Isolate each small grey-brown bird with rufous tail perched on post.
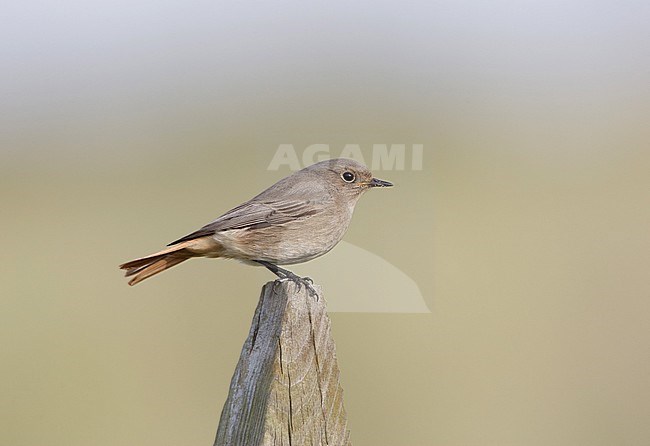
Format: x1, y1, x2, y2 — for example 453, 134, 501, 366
120, 158, 392, 285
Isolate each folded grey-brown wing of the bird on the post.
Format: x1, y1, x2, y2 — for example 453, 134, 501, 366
167, 200, 323, 246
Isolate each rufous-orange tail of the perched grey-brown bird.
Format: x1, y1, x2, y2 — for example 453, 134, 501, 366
120, 240, 216, 285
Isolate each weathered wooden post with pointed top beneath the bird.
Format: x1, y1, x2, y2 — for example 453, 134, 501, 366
214, 279, 351, 446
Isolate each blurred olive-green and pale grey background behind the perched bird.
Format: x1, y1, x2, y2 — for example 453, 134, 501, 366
0, 0, 650, 446
